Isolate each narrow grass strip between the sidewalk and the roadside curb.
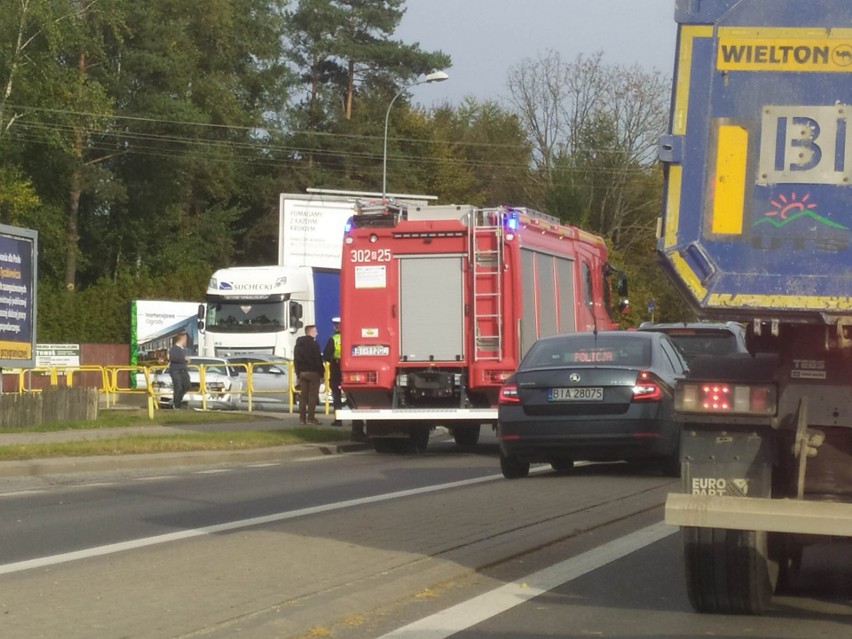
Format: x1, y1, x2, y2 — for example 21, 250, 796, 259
0, 428, 346, 461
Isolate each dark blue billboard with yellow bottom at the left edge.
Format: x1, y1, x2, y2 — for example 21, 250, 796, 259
0, 224, 38, 368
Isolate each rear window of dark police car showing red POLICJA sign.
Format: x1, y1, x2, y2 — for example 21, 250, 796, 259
520, 336, 651, 370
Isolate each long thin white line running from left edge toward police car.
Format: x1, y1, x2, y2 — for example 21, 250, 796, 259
0, 475, 503, 575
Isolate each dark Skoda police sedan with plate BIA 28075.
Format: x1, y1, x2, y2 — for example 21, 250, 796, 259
497, 331, 687, 479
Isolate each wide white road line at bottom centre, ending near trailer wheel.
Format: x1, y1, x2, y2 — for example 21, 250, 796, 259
378, 522, 678, 639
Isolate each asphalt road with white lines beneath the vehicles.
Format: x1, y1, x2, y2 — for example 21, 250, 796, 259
0, 431, 852, 639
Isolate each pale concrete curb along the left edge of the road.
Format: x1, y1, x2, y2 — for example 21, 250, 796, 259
0, 442, 369, 477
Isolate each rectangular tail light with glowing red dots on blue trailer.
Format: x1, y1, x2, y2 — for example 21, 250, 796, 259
675, 382, 776, 415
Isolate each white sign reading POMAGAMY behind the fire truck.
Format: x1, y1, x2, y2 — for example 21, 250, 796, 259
278, 194, 355, 270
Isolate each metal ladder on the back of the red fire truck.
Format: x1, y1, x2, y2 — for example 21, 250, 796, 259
468, 209, 503, 361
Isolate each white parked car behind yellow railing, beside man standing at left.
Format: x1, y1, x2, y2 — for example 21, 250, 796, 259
151, 357, 244, 410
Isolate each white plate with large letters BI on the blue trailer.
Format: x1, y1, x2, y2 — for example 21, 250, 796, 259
757, 104, 852, 186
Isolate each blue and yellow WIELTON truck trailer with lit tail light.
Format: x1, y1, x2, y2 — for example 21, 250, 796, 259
658, 0, 852, 613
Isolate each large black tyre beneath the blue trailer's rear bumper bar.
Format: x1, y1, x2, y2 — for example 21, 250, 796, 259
681, 527, 777, 615
